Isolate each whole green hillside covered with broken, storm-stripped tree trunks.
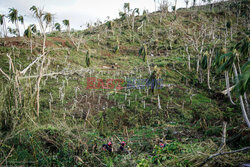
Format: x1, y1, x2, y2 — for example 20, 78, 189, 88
0, 0, 250, 166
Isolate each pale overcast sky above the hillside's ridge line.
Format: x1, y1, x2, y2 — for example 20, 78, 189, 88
0, 0, 188, 32
